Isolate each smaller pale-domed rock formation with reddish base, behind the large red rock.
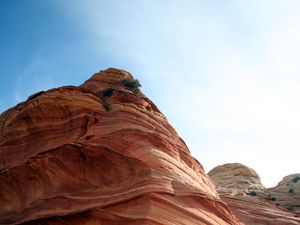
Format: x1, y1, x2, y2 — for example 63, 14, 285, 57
208, 163, 300, 225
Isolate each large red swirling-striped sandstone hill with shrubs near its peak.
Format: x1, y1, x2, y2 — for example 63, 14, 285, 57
0, 69, 240, 225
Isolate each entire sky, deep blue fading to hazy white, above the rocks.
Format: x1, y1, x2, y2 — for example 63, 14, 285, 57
0, 0, 300, 186
